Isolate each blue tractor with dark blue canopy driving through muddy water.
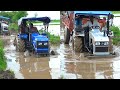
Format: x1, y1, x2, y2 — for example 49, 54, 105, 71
14, 17, 50, 55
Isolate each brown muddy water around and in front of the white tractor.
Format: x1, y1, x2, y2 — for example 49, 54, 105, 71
60, 28, 120, 79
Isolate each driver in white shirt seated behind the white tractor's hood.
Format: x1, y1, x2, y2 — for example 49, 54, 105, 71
82, 16, 100, 28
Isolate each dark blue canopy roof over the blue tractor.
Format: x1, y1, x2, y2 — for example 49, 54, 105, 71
18, 17, 51, 25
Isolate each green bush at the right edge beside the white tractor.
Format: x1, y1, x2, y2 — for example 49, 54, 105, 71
110, 26, 120, 45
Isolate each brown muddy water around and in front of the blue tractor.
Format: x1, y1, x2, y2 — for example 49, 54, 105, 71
4, 36, 60, 79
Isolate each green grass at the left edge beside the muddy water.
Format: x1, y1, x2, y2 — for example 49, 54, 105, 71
0, 40, 7, 70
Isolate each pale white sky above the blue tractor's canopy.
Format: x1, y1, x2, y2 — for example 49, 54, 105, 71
27, 11, 60, 19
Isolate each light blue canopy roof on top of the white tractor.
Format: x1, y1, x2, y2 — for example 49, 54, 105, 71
74, 11, 112, 15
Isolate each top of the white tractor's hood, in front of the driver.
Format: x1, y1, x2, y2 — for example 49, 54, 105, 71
90, 29, 109, 41
